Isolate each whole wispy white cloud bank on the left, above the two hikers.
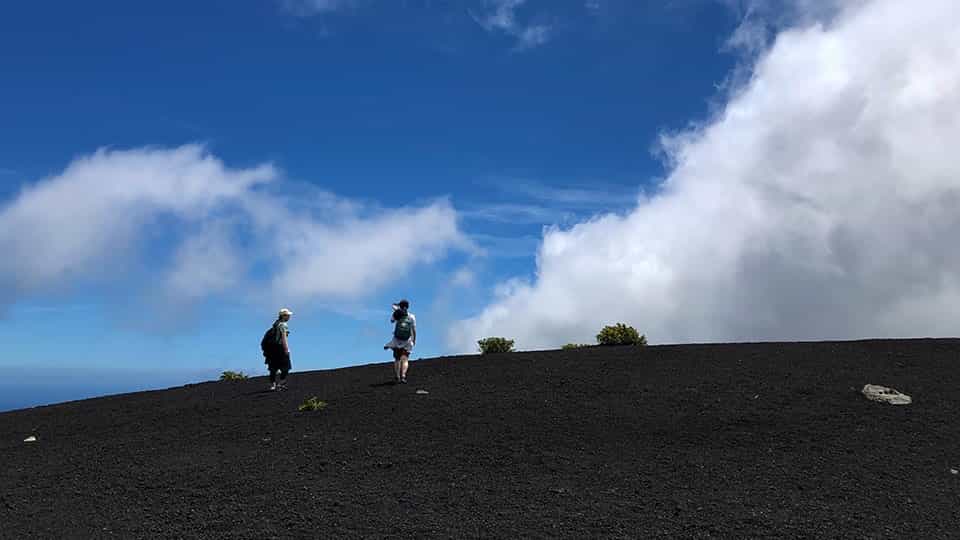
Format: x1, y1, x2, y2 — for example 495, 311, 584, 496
0, 145, 468, 312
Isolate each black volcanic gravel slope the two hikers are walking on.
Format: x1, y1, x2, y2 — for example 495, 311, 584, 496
0, 340, 960, 539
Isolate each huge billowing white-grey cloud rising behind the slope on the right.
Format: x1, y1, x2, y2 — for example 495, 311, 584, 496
449, 0, 960, 351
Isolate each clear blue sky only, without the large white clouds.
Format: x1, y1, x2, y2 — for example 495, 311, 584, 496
0, 0, 736, 376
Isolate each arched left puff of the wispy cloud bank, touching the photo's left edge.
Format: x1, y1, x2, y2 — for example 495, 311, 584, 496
0, 145, 277, 291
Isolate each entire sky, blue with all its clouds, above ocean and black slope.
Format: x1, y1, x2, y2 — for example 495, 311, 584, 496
0, 0, 960, 408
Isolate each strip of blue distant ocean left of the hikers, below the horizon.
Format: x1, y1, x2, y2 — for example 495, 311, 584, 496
0, 366, 223, 412
